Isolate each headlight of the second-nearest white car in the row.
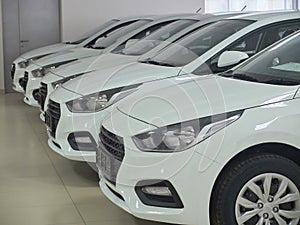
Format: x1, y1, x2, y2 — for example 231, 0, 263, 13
66, 84, 141, 113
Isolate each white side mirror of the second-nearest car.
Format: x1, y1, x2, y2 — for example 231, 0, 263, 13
218, 51, 249, 67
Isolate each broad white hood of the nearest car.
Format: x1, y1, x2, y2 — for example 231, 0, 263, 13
115, 75, 298, 127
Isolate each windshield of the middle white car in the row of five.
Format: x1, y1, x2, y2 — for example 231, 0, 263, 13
121, 19, 197, 56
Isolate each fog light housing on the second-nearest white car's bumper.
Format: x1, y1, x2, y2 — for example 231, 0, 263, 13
68, 132, 97, 151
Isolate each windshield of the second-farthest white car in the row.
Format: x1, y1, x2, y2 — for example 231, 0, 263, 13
92, 20, 151, 49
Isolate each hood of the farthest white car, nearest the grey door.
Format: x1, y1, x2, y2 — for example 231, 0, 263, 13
20, 43, 76, 59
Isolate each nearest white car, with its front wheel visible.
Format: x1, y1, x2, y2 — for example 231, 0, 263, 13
97, 33, 300, 225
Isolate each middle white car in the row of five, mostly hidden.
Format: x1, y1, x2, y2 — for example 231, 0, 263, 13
38, 13, 241, 120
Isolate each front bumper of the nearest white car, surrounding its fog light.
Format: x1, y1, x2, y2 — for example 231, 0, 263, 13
96, 111, 221, 225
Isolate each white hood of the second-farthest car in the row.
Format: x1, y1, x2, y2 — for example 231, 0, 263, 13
33, 48, 102, 67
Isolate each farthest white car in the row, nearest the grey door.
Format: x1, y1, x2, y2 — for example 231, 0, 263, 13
11, 17, 140, 93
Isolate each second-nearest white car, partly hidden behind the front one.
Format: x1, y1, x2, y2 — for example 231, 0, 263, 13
46, 12, 300, 162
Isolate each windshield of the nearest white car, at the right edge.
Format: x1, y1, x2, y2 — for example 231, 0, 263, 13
220, 33, 300, 85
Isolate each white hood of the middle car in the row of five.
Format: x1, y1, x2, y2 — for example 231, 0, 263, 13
52, 53, 138, 78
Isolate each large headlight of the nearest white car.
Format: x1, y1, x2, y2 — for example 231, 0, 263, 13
132, 111, 243, 152
